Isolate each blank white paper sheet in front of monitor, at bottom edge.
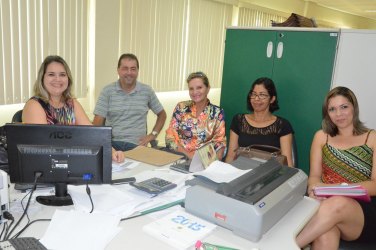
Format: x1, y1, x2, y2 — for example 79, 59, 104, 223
41, 210, 121, 250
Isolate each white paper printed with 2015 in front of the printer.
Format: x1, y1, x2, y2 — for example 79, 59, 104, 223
143, 210, 216, 249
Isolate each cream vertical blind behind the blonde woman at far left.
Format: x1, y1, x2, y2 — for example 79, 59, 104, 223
0, 0, 88, 105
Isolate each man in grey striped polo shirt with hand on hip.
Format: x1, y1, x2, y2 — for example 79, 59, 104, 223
93, 54, 166, 151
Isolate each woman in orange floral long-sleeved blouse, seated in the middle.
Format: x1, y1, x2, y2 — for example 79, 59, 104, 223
166, 72, 226, 159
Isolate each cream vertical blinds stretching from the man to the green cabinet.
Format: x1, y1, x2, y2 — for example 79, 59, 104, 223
119, 0, 232, 92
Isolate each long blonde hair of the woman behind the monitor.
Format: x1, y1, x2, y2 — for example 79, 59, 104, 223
34, 55, 73, 103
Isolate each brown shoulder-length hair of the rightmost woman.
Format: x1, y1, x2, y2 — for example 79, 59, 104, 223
322, 86, 369, 136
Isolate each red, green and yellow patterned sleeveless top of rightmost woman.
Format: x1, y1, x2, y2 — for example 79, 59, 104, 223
321, 130, 373, 184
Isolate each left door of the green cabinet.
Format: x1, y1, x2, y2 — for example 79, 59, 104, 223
220, 29, 276, 139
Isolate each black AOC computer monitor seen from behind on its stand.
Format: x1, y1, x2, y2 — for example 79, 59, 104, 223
5, 123, 112, 206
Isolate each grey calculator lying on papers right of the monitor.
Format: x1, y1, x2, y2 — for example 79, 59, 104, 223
129, 177, 177, 194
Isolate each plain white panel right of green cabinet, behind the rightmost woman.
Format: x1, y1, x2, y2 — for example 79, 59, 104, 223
332, 30, 376, 129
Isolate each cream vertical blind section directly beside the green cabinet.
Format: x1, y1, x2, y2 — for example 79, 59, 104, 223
181, 0, 233, 89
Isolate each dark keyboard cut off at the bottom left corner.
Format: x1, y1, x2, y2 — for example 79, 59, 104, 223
0, 237, 47, 250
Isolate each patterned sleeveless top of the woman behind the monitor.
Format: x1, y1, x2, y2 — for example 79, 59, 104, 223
31, 96, 76, 125
